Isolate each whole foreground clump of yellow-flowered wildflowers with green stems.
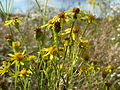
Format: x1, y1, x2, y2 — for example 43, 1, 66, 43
0, 0, 118, 90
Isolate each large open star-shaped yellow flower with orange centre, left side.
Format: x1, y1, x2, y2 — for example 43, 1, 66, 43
8, 52, 26, 65
